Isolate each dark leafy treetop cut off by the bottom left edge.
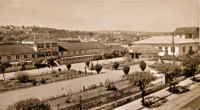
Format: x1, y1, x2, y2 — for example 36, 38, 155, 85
7, 98, 51, 110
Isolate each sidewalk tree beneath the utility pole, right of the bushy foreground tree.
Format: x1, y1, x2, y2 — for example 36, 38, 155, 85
157, 64, 178, 91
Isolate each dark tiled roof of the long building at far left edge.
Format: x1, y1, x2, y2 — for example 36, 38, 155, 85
0, 44, 36, 56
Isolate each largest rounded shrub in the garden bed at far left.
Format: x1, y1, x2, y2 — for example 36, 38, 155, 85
15, 72, 30, 83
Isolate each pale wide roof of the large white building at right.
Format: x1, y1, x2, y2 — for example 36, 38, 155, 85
133, 36, 198, 45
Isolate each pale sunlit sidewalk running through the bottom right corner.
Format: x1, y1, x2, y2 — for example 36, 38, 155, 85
114, 75, 200, 110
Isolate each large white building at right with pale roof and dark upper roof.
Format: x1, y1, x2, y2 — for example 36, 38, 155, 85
132, 28, 199, 56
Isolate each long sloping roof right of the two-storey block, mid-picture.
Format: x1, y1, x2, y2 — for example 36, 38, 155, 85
58, 42, 106, 50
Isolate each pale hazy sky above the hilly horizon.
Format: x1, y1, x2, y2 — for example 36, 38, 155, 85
0, 0, 199, 32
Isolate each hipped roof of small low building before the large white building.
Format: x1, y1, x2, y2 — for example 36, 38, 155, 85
128, 45, 162, 53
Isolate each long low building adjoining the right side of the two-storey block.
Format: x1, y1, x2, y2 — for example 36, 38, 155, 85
57, 42, 106, 64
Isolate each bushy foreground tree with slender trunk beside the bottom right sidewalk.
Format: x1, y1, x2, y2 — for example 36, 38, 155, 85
128, 71, 156, 104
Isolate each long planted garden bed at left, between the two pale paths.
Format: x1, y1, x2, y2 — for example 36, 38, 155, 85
0, 70, 94, 93
